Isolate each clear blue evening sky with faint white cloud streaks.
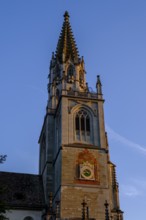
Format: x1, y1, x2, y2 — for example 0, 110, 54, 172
0, 0, 146, 220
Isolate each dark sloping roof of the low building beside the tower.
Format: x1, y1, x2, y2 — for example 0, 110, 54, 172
0, 172, 44, 210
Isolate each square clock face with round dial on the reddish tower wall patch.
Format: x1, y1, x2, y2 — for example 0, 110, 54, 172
80, 164, 95, 180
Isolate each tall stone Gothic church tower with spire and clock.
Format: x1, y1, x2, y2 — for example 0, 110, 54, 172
39, 12, 123, 220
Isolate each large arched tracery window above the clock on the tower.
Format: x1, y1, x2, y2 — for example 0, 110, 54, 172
75, 109, 91, 142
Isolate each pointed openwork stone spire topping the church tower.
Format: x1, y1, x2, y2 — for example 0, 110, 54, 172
56, 11, 79, 63
